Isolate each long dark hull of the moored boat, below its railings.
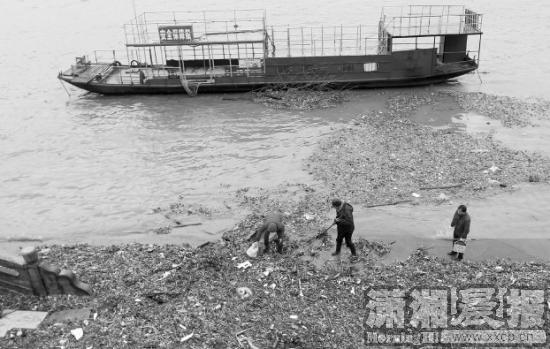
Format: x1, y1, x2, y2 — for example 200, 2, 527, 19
59, 49, 477, 95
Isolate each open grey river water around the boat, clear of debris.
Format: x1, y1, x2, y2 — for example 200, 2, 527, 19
0, 0, 550, 245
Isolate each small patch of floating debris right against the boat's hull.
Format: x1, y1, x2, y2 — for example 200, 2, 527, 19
253, 85, 348, 110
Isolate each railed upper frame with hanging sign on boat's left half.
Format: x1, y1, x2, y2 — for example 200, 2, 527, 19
124, 10, 266, 65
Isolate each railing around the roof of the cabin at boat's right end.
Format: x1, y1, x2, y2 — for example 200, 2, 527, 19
380, 5, 483, 37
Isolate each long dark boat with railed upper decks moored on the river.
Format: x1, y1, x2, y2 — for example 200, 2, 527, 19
58, 5, 482, 96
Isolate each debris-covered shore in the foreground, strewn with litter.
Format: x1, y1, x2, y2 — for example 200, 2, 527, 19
0, 239, 550, 349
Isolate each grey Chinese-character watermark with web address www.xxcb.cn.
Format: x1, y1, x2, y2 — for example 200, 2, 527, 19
364, 286, 548, 346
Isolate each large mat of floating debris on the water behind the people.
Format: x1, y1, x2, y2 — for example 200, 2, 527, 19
306, 94, 550, 206
